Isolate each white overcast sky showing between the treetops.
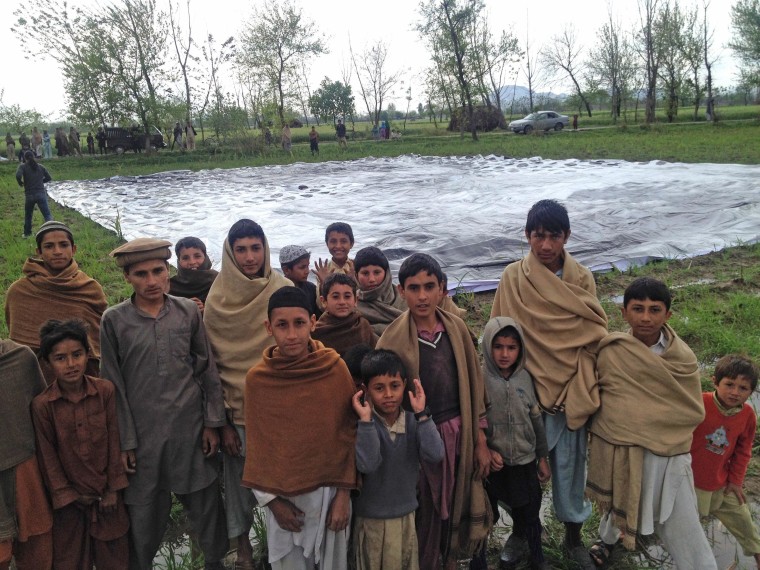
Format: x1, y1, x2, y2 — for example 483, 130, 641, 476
0, 0, 737, 120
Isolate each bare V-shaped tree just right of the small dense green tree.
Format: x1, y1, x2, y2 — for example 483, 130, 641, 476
348, 40, 401, 126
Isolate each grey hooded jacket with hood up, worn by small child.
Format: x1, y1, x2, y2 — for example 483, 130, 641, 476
482, 317, 549, 466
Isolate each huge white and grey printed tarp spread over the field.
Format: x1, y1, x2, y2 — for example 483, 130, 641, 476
48, 156, 760, 290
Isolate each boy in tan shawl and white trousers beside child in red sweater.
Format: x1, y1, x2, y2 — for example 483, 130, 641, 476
587, 277, 716, 570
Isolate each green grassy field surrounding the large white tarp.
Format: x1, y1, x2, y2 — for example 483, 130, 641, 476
0, 117, 760, 568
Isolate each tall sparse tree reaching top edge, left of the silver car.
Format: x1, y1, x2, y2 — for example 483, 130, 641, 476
417, 0, 484, 140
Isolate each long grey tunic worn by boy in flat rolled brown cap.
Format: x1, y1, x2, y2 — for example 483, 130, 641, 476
100, 295, 226, 505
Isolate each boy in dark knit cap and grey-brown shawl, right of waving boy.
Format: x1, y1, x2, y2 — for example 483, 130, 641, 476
354, 246, 407, 336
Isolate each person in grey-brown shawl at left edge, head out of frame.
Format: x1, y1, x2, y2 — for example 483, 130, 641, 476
0, 340, 53, 570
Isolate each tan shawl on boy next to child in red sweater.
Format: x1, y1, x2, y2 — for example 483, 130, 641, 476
586, 325, 705, 548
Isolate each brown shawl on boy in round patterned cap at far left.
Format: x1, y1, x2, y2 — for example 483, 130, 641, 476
5, 257, 108, 359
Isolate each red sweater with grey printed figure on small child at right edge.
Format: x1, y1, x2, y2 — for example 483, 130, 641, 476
691, 392, 757, 491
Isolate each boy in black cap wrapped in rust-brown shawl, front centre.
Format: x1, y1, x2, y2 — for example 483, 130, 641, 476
243, 287, 356, 570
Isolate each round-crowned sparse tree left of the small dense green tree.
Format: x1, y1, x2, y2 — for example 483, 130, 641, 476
238, 0, 327, 125
